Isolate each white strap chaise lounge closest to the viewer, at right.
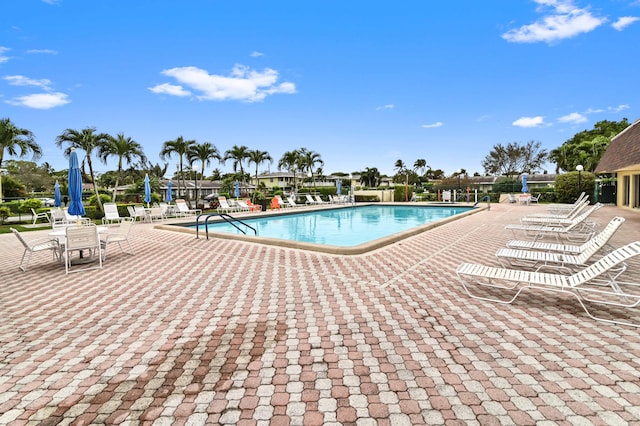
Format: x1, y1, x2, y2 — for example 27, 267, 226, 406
456, 241, 640, 327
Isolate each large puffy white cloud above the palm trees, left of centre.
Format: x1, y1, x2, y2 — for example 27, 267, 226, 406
149, 65, 296, 102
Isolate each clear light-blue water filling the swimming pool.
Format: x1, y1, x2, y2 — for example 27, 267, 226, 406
189, 205, 472, 247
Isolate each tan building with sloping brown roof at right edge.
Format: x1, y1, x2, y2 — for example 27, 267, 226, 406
595, 119, 640, 209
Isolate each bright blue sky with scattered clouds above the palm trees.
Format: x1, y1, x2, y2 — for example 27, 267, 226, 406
0, 0, 640, 175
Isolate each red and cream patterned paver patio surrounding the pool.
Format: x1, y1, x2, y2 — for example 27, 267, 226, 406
0, 204, 640, 425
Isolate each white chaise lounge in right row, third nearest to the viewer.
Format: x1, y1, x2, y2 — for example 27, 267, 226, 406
505, 204, 602, 242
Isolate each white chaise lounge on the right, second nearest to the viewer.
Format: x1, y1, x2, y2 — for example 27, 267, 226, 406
496, 217, 624, 273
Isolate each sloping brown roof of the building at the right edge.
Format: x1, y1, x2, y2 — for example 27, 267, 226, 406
595, 116, 640, 173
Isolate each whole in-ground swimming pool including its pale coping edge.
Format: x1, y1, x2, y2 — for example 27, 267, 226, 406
160, 203, 478, 254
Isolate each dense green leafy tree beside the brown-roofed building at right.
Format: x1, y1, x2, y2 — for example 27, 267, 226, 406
549, 118, 629, 173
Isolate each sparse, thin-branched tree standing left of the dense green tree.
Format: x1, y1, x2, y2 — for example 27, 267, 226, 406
482, 141, 548, 177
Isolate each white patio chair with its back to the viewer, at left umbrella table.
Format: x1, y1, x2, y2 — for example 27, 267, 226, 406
64, 224, 102, 274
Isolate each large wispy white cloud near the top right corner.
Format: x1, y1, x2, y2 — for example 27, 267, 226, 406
502, 0, 607, 43
